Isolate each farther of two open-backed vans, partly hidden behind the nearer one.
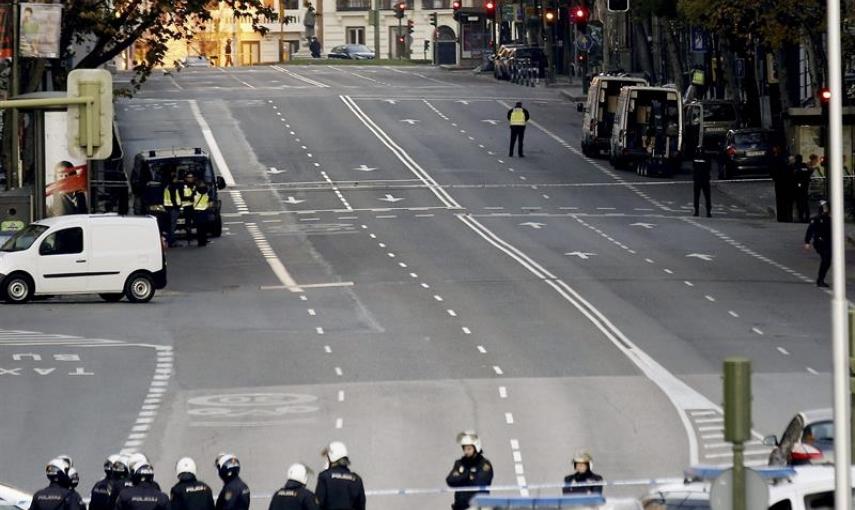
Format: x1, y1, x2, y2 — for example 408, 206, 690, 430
576, 74, 648, 157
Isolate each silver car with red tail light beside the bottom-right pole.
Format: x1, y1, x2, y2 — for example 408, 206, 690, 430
763, 408, 834, 465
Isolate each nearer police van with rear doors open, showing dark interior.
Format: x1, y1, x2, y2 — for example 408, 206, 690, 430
609, 85, 683, 175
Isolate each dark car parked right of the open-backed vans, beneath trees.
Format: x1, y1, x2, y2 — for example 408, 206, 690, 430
718, 128, 781, 179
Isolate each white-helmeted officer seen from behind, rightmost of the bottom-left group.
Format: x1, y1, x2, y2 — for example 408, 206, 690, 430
315, 441, 365, 510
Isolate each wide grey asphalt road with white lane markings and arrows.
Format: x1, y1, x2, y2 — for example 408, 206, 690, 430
0, 66, 844, 509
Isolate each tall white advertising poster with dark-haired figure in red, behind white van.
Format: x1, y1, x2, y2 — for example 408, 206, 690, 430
44, 112, 89, 217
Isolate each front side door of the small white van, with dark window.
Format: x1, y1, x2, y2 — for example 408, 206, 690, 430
36, 226, 89, 294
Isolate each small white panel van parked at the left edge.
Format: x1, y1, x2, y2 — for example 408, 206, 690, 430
0, 214, 166, 303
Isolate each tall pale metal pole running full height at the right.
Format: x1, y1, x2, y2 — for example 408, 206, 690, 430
826, 0, 852, 508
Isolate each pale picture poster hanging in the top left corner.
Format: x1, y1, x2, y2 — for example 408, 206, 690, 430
18, 2, 62, 58
